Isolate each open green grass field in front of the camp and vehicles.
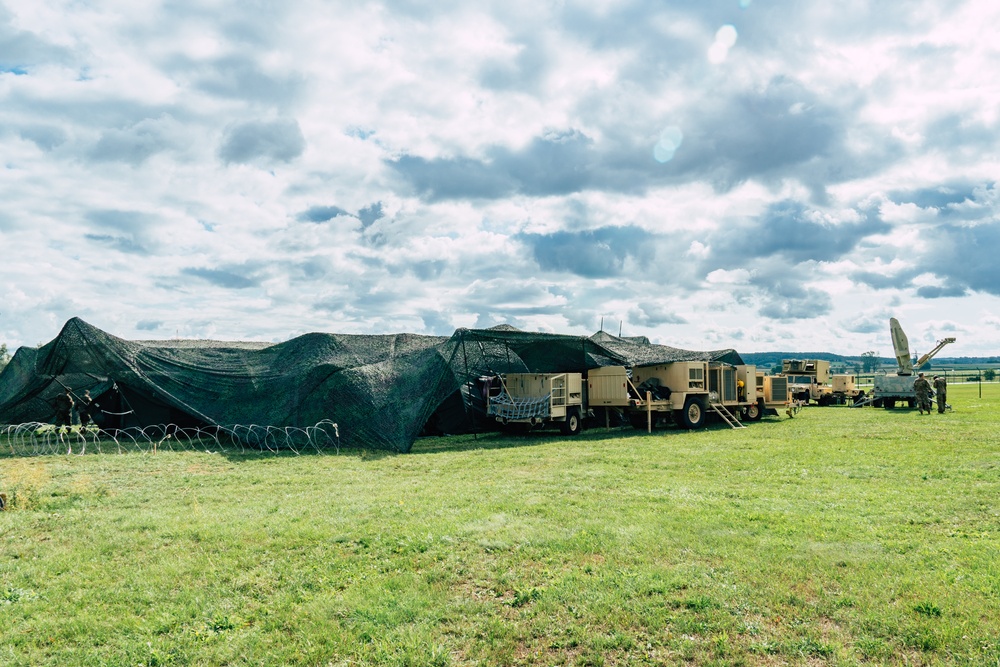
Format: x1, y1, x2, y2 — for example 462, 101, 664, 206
0, 384, 1000, 666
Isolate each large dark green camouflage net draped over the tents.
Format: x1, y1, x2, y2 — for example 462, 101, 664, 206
0, 318, 742, 452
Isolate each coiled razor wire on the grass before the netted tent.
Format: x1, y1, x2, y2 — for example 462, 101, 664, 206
0, 420, 340, 456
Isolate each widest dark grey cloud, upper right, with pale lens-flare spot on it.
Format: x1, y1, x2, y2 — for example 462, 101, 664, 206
386, 76, 865, 201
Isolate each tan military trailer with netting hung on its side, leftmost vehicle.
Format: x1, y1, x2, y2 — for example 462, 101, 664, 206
486, 373, 587, 435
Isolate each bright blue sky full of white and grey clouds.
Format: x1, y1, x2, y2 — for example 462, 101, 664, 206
0, 0, 1000, 356
